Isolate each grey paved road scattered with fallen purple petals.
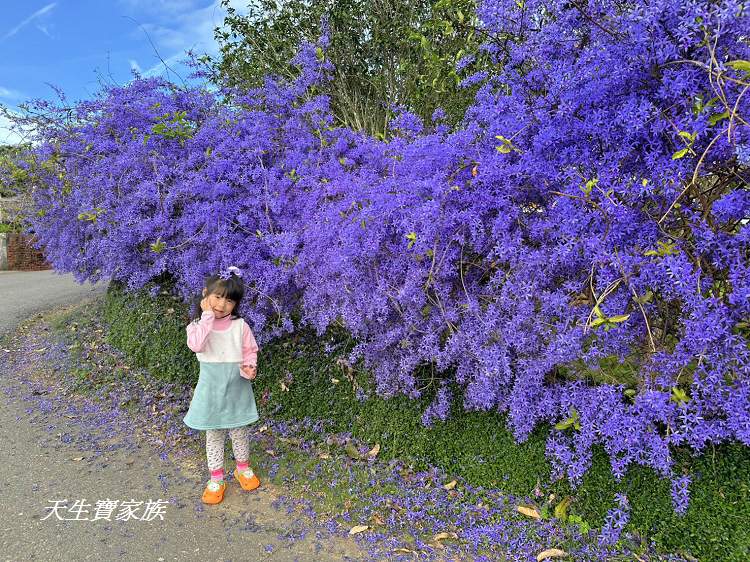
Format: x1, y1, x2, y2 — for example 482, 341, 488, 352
0, 272, 366, 561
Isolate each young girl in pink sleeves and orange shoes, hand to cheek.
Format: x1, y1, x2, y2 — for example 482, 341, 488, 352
183, 267, 260, 504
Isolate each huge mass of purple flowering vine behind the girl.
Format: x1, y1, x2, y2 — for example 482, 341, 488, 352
11, 0, 750, 544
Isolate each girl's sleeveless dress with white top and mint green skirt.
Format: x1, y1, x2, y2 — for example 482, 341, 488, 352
183, 318, 258, 430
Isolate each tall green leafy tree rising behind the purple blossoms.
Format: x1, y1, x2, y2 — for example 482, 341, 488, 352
210, 0, 484, 135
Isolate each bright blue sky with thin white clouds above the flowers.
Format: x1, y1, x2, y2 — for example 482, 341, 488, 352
0, 0, 247, 144
